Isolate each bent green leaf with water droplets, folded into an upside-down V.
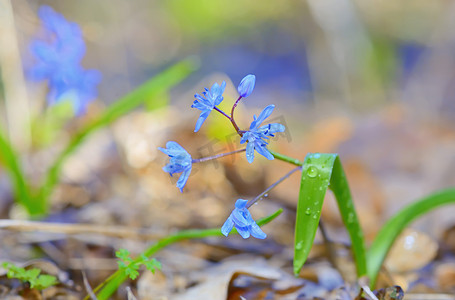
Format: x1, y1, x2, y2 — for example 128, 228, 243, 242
294, 153, 367, 276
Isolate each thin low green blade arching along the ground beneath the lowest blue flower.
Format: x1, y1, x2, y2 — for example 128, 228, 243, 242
94, 208, 283, 300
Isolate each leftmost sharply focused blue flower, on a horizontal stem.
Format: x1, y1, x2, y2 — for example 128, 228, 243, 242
158, 142, 192, 192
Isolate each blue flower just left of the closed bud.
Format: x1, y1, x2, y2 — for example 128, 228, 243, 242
191, 81, 226, 132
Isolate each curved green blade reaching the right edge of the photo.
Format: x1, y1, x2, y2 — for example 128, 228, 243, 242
367, 188, 455, 287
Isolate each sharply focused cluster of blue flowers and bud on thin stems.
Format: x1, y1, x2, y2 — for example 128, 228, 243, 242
158, 74, 285, 239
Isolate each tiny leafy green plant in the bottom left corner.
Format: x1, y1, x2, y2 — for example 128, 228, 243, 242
2, 262, 58, 290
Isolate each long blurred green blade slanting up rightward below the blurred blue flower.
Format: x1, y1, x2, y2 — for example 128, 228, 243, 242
39, 59, 197, 211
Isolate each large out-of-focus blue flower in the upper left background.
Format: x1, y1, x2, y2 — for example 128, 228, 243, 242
28, 6, 101, 115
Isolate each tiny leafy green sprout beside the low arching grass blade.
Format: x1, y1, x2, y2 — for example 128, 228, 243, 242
115, 249, 161, 280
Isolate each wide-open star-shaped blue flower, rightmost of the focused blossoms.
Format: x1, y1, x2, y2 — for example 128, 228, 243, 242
240, 104, 285, 163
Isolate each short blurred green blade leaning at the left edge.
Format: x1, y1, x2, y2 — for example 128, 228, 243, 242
0, 132, 39, 215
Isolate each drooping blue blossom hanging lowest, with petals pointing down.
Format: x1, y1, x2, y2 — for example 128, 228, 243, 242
221, 199, 267, 239
